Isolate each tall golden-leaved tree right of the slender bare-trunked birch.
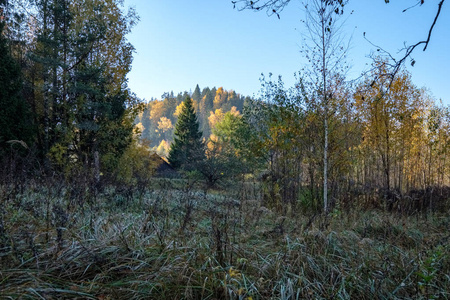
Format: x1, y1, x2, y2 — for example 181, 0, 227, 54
355, 61, 427, 191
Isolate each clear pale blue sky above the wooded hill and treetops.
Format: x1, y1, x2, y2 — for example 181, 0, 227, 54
124, 0, 450, 105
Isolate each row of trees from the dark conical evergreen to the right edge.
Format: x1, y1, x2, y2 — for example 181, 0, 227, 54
168, 66, 450, 212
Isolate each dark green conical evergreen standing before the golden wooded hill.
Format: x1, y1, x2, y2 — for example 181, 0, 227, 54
169, 97, 205, 171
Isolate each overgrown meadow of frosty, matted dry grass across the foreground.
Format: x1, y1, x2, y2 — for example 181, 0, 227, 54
0, 182, 450, 299
